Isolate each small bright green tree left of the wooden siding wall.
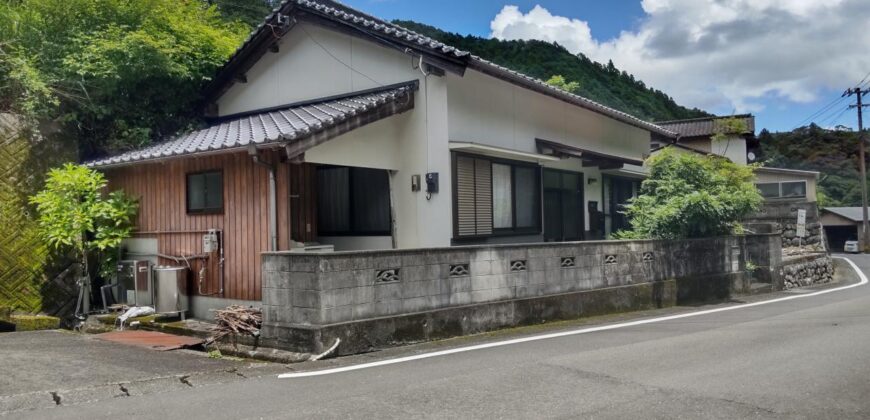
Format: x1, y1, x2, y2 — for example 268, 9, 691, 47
30, 164, 138, 316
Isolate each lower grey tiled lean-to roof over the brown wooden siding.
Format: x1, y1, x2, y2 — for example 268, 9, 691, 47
85, 81, 417, 167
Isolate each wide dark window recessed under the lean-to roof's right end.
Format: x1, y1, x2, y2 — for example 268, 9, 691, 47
317, 166, 391, 236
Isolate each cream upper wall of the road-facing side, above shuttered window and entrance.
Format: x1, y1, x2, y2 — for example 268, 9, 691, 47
447, 70, 650, 230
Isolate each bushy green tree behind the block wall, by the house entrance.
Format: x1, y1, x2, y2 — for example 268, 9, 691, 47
618, 148, 762, 239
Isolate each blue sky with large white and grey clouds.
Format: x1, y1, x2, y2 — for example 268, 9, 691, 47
343, 0, 870, 131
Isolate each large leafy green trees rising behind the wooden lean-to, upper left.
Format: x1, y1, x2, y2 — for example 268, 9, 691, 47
0, 0, 249, 157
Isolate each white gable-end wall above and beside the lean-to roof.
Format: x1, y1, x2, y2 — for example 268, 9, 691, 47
218, 23, 452, 249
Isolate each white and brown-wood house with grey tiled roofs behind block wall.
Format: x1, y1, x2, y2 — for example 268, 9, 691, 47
87, 0, 764, 317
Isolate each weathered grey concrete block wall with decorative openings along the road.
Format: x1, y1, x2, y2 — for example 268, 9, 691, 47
262, 234, 781, 328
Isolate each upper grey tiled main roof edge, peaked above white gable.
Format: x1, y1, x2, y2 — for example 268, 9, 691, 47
211, 0, 676, 137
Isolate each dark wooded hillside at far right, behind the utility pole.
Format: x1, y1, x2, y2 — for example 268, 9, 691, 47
758, 124, 861, 206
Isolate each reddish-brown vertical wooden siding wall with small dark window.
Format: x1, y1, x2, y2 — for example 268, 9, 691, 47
105, 152, 297, 300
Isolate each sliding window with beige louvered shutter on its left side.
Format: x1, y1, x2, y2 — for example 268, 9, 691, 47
453, 154, 541, 237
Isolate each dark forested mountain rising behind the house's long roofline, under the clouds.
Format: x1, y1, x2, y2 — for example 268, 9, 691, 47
393, 20, 709, 121
